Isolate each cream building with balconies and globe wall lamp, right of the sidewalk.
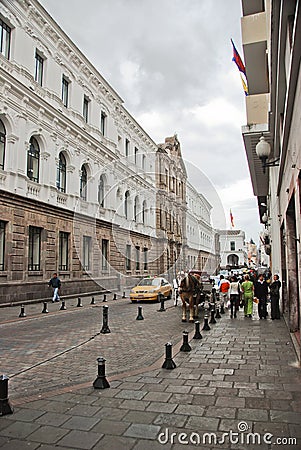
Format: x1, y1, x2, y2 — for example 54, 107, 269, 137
241, 0, 301, 356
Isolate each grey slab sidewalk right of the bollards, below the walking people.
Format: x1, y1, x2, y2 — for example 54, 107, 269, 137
0, 308, 301, 450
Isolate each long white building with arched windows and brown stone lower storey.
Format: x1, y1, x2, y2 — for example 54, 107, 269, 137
0, 0, 219, 303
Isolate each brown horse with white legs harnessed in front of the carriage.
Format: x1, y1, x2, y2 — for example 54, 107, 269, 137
179, 273, 202, 322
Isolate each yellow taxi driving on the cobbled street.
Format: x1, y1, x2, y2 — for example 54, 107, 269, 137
130, 277, 172, 303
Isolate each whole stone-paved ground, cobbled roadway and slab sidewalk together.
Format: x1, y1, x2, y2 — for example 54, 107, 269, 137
0, 299, 301, 450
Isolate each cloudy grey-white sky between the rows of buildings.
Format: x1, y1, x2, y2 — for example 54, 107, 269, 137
40, 0, 261, 242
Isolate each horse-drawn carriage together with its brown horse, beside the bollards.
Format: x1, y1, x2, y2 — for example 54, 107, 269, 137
179, 270, 217, 322
